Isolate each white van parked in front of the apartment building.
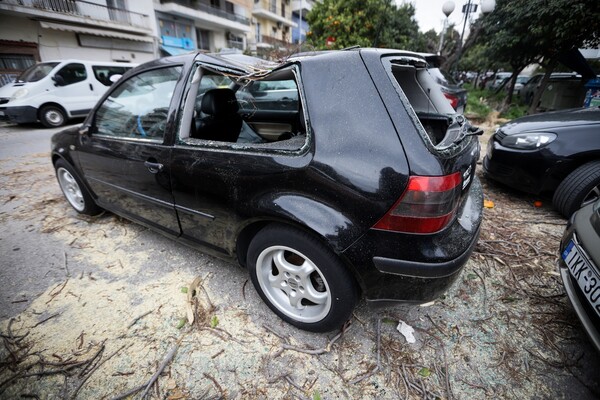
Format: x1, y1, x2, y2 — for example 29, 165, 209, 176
0, 60, 137, 128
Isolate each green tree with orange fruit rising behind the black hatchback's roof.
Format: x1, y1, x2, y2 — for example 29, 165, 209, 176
307, 0, 426, 50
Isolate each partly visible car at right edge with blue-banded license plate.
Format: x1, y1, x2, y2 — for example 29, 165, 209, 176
559, 201, 600, 352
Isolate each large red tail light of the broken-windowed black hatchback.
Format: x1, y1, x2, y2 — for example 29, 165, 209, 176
373, 172, 462, 233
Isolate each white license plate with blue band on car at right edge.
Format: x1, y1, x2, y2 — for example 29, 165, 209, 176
562, 241, 600, 316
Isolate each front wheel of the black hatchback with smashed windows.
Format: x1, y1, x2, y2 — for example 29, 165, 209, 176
54, 160, 102, 215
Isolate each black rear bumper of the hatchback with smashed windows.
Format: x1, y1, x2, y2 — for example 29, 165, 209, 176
344, 179, 483, 302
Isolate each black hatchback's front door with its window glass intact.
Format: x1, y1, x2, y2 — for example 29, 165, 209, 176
79, 66, 182, 235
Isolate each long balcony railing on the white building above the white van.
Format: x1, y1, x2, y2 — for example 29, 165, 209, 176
0, 0, 149, 28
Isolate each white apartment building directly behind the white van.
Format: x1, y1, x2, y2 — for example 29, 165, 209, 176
0, 0, 158, 85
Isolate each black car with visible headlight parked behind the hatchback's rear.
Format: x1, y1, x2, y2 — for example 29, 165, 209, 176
483, 107, 600, 217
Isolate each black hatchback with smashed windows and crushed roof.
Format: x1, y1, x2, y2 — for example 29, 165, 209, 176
52, 49, 482, 331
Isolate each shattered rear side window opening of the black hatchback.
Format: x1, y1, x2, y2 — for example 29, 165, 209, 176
179, 66, 307, 152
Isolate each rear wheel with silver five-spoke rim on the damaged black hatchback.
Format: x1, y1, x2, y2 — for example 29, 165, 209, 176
248, 224, 358, 332
